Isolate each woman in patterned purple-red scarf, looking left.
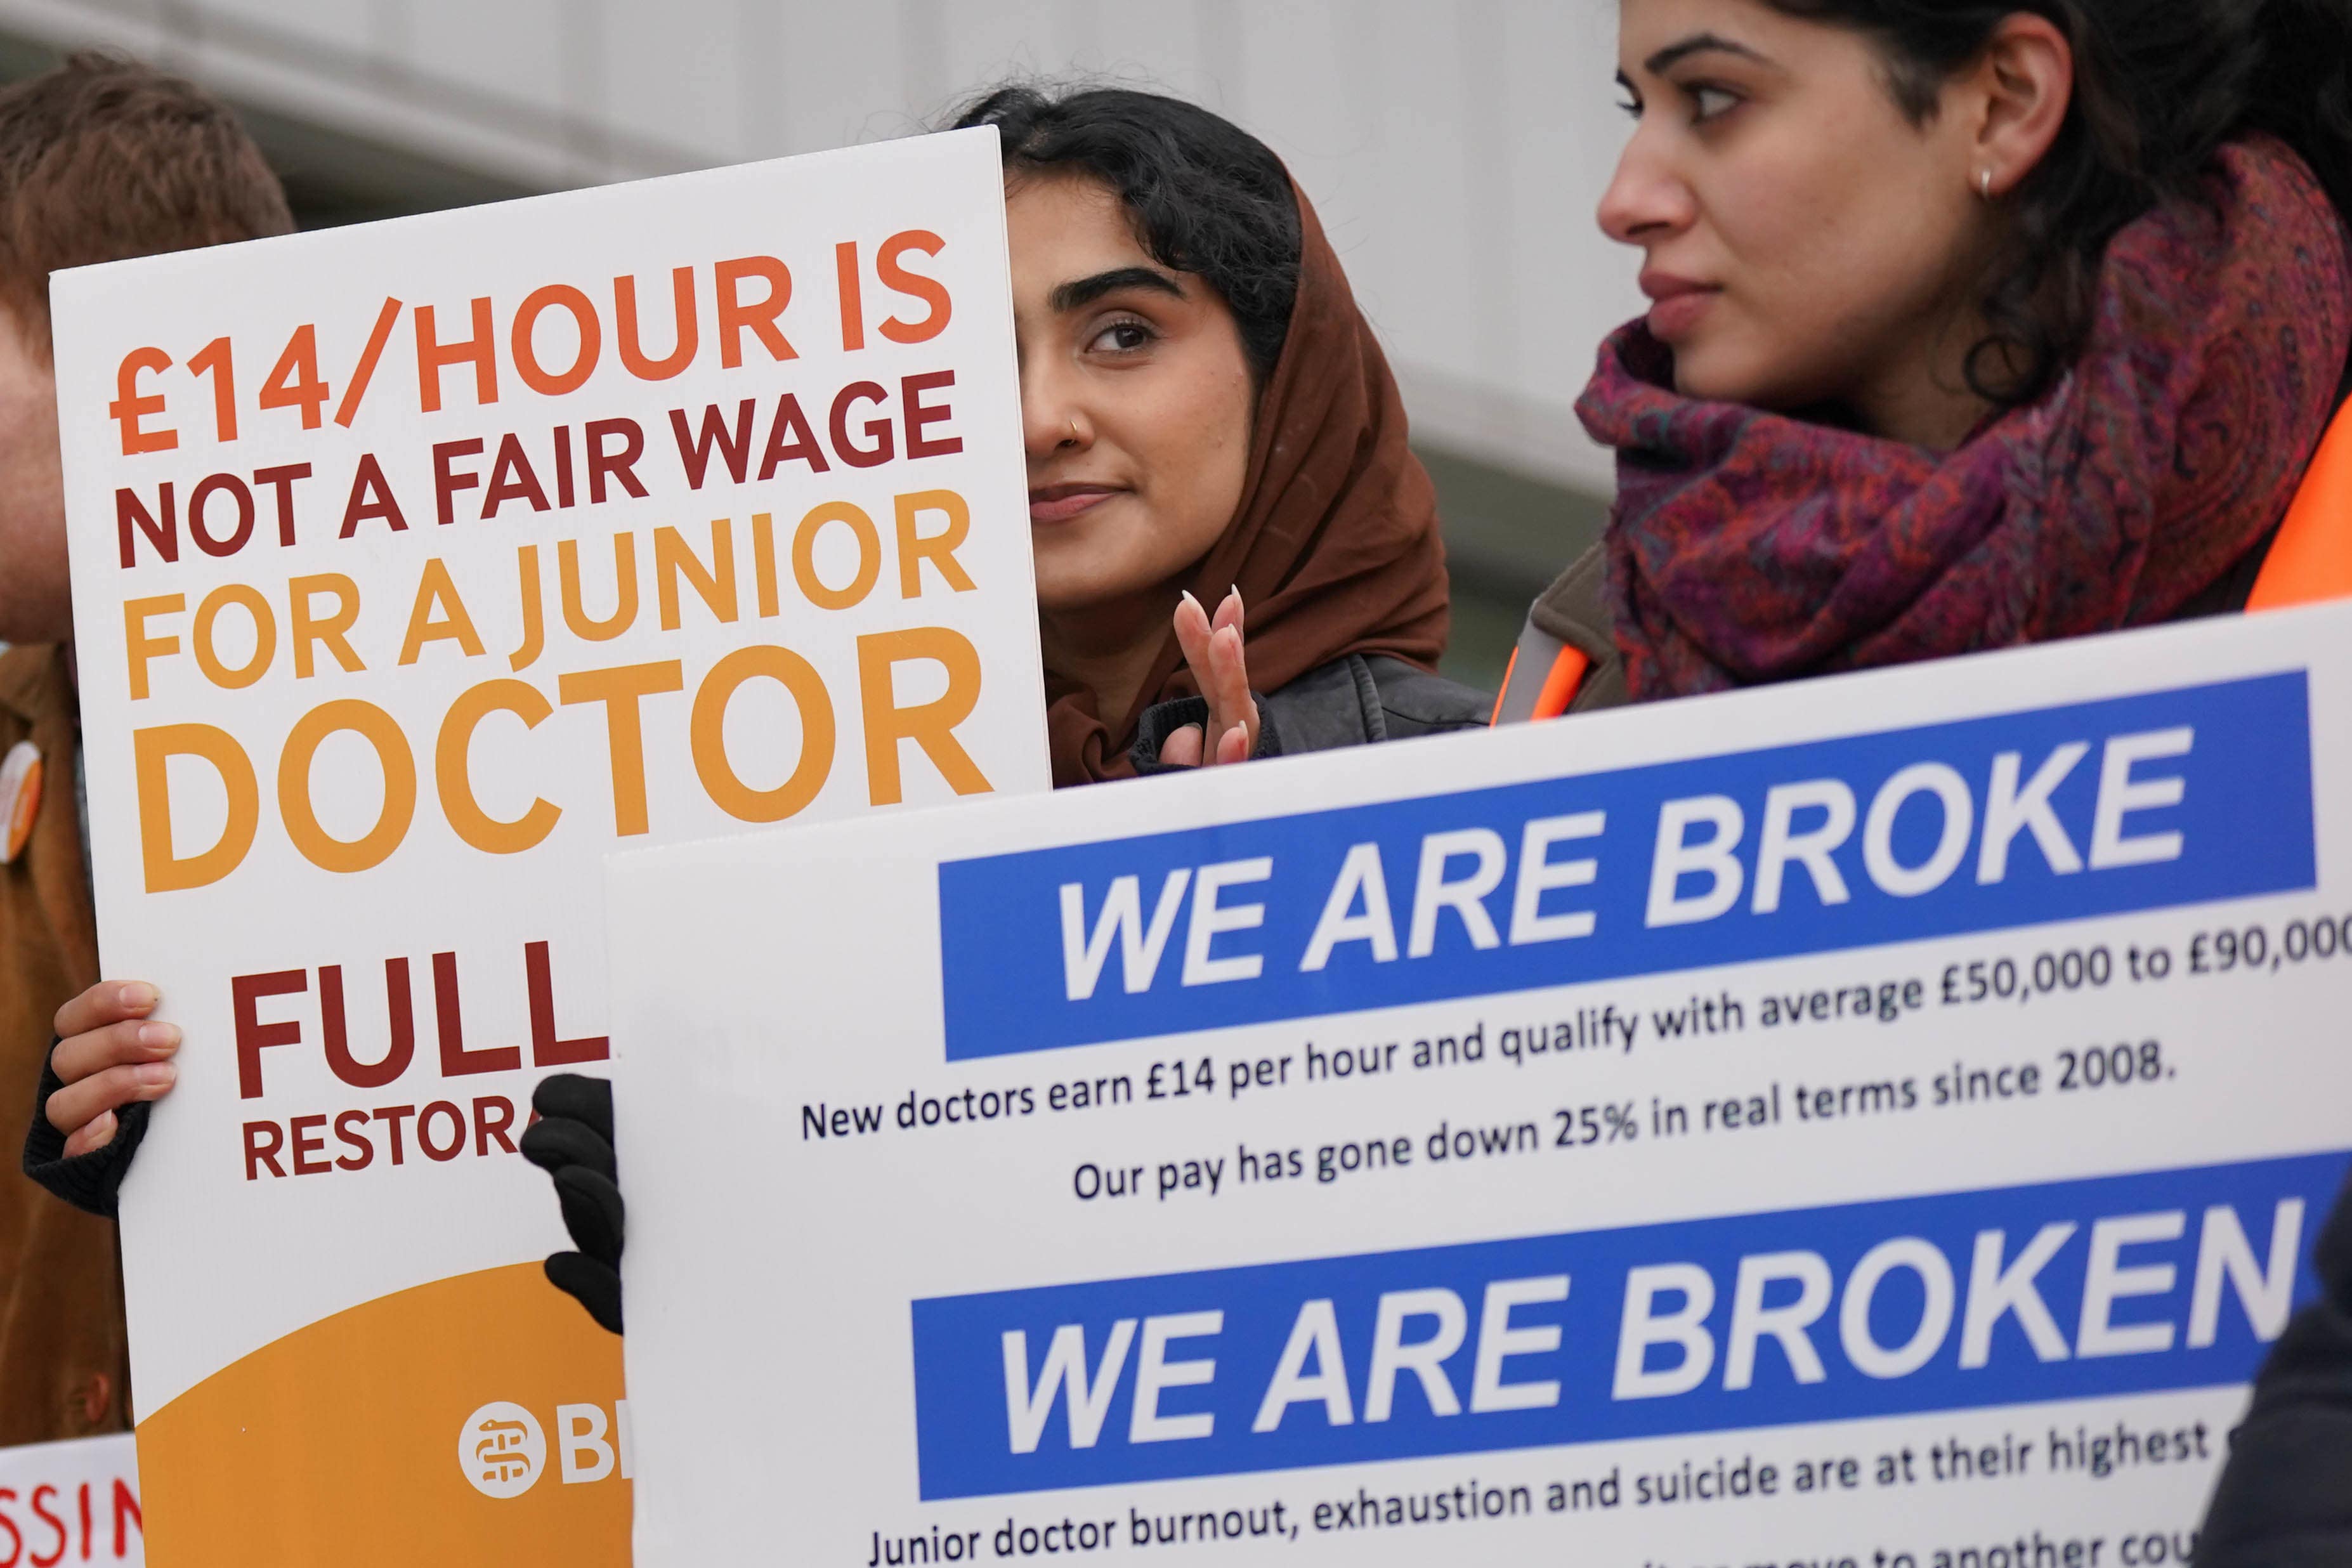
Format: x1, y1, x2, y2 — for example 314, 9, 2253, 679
1498, 0, 2352, 719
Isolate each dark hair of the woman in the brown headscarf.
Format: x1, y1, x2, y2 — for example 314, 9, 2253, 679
955, 84, 1298, 383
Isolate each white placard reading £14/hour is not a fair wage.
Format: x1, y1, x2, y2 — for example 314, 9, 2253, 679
54, 132, 1049, 1568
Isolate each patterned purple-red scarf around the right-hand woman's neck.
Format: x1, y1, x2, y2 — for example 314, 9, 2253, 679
1576, 139, 2352, 698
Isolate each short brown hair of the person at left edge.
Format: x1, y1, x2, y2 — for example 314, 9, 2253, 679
0, 52, 294, 343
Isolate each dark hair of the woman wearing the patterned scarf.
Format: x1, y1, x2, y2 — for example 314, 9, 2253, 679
1768, 0, 2352, 407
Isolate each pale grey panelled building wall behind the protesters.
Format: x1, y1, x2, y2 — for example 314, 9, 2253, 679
0, 0, 1639, 492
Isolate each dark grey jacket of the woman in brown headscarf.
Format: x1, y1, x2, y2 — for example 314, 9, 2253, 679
1129, 653, 1494, 773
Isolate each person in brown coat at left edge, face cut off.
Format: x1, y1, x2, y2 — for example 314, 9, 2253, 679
0, 54, 294, 1446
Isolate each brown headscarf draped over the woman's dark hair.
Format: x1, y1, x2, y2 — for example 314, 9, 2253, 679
1047, 186, 1446, 788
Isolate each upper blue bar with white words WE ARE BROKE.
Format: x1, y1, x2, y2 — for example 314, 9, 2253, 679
938, 670, 2316, 1060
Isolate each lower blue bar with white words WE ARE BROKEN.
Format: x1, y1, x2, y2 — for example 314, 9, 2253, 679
913, 1154, 2348, 1500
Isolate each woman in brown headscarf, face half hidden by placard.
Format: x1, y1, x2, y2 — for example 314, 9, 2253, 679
957, 87, 1489, 785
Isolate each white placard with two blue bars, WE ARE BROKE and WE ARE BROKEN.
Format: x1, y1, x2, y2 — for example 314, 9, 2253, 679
609, 597, 2352, 1568
